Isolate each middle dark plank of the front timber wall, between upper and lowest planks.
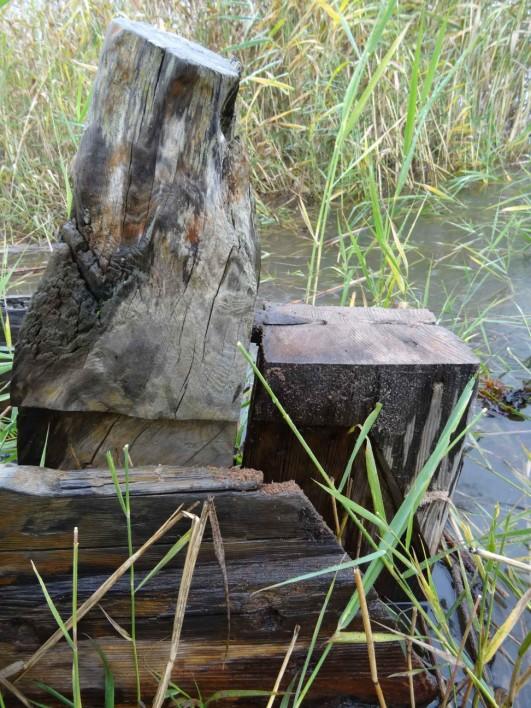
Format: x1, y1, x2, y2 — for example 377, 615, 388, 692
0, 546, 364, 650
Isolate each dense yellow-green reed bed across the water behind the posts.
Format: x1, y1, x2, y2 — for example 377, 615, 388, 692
0, 0, 531, 241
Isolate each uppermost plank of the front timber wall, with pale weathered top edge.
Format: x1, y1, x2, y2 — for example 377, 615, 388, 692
0, 466, 331, 551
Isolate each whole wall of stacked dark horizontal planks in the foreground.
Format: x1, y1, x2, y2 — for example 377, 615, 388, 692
0, 465, 434, 706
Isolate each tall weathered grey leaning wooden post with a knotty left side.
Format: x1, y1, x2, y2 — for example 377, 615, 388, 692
11, 19, 259, 468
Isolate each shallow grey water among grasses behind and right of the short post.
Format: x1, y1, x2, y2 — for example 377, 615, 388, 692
261, 182, 531, 707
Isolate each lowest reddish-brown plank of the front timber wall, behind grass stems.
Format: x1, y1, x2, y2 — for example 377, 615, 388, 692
0, 637, 435, 706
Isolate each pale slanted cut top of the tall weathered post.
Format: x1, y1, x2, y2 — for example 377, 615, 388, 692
108, 17, 240, 79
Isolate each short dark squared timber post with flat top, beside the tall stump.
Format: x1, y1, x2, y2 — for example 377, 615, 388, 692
244, 305, 479, 552
